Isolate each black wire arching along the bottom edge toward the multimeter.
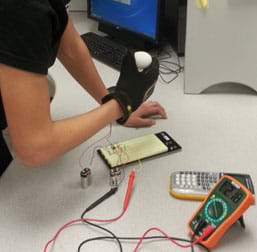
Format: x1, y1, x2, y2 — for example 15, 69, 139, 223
78, 236, 210, 252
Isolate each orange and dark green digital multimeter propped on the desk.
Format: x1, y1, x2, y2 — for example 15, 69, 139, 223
188, 175, 254, 248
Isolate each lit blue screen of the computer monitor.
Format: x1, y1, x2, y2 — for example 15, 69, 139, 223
89, 0, 159, 40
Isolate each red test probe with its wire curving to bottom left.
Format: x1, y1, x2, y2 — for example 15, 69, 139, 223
44, 171, 135, 252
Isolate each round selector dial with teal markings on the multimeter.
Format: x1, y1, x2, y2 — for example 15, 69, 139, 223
204, 197, 228, 224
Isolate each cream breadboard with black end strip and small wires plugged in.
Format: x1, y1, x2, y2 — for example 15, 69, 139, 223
97, 131, 181, 168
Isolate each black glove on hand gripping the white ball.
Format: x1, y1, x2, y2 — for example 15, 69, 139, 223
102, 50, 159, 124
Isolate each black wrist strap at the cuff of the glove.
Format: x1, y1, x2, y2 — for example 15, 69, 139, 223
102, 92, 132, 124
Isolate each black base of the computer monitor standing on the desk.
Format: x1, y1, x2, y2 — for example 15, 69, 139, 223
98, 22, 159, 51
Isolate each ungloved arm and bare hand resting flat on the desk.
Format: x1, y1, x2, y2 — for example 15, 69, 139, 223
58, 18, 167, 127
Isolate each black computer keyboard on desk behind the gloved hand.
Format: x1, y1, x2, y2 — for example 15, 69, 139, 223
81, 32, 128, 70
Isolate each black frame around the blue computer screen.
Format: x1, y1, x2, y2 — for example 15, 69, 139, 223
87, 0, 162, 43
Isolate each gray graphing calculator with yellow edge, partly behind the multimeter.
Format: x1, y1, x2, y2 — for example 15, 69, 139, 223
169, 171, 254, 200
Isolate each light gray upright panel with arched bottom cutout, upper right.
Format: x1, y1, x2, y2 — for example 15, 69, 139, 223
185, 0, 257, 93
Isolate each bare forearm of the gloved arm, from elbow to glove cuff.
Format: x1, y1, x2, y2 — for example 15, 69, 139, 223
24, 100, 122, 166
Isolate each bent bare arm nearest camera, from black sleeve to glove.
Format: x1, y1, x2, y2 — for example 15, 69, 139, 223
0, 65, 122, 166
